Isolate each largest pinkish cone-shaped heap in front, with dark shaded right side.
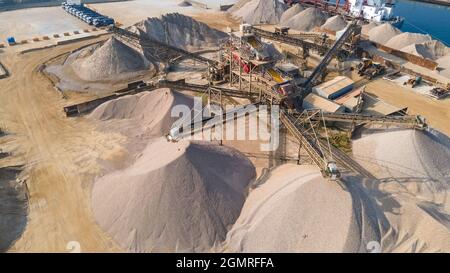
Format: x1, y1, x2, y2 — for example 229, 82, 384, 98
92, 138, 255, 252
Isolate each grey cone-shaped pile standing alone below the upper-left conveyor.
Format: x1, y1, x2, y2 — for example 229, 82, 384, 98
71, 37, 153, 81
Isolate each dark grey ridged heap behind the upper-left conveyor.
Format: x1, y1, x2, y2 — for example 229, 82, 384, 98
131, 13, 227, 49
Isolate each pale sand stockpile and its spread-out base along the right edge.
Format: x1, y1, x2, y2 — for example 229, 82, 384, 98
352, 129, 450, 252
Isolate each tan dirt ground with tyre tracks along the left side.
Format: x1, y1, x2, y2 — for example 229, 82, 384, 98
0, 37, 125, 252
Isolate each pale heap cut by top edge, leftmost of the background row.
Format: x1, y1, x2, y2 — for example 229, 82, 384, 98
231, 0, 287, 24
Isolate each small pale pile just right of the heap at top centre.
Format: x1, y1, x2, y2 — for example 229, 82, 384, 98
285, 8, 327, 31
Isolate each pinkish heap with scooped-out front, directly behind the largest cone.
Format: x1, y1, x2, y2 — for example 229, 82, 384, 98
89, 88, 193, 136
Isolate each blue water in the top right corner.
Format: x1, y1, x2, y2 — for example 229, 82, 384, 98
394, 0, 450, 46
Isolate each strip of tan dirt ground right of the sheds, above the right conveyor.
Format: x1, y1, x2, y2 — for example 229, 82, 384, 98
366, 79, 450, 136
